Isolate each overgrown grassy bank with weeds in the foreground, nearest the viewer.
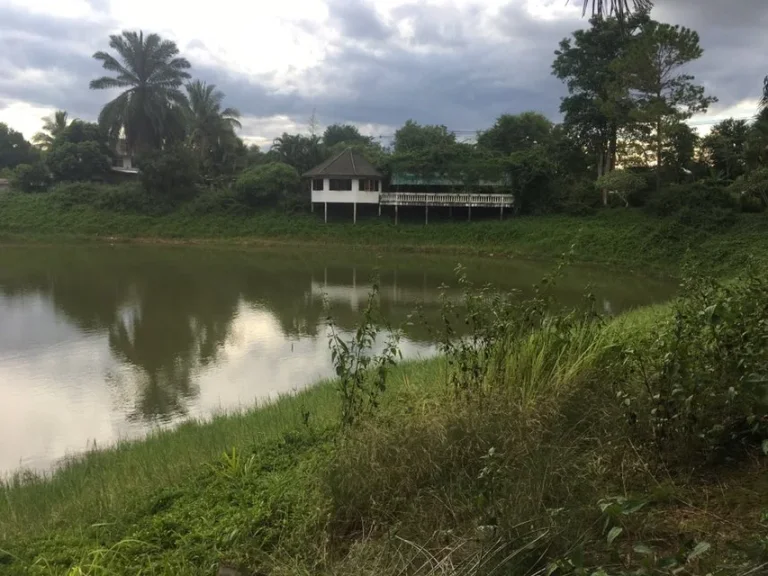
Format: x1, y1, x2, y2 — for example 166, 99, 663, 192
0, 276, 768, 576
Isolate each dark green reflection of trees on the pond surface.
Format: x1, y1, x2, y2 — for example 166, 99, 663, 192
0, 247, 676, 420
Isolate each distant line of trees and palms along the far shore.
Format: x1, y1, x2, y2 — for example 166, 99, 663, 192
0, 7, 768, 226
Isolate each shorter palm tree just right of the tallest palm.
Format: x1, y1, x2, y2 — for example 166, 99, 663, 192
185, 80, 243, 174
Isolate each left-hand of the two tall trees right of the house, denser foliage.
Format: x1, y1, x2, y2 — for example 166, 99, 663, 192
552, 12, 649, 189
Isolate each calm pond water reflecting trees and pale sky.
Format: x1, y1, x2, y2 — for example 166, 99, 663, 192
0, 246, 674, 474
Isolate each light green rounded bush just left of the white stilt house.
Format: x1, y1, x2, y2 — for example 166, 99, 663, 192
235, 162, 301, 206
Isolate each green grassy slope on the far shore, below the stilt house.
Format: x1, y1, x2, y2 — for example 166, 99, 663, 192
0, 194, 768, 271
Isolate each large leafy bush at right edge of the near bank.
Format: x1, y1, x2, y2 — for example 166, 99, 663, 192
619, 274, 768, 463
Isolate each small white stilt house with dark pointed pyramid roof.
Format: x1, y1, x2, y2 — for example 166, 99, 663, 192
303, 148, 382, 222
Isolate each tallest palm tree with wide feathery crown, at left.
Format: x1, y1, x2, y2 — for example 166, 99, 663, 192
91, 31, 190, 151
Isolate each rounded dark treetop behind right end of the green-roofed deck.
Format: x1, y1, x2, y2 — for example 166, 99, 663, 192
477, 112, 553, 154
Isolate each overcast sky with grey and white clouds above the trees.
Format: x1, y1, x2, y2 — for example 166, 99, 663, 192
0, 0, 768, 145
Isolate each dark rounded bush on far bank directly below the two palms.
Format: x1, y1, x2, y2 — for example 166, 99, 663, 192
139, 146, 199, 205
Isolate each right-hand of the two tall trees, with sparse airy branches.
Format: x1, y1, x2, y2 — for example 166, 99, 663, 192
619, 20, 717, 189
